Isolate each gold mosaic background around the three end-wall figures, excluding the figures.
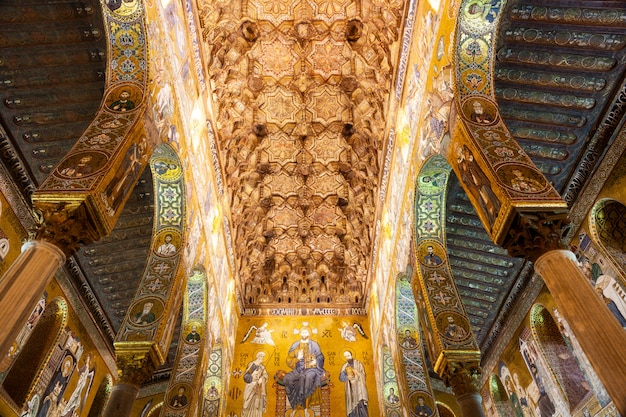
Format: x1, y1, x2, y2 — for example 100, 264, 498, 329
224, 316, 379, 417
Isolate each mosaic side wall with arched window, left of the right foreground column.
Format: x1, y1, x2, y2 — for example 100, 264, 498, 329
482, 289, 617, 417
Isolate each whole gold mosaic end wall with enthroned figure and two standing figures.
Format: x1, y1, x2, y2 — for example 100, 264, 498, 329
226, 316, 379, 417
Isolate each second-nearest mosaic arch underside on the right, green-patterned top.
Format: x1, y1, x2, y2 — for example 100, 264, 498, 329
414, 155, 480, 374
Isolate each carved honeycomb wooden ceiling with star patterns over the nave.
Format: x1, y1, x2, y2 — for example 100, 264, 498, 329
200, 0, 403, 307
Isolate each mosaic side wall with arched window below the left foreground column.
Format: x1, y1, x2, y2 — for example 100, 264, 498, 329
0, 281, 112, 417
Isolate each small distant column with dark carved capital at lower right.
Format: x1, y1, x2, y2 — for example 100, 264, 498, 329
443, 362, 485, 417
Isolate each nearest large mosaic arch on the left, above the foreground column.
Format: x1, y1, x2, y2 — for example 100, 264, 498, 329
33, 1, 158, 253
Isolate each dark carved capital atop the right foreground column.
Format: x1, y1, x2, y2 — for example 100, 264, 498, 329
502, 212, 569, 262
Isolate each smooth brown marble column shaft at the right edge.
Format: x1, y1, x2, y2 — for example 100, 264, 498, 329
535, 250, 626, 415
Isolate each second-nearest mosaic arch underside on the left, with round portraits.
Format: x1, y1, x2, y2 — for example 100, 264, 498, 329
114, 144, 186, 366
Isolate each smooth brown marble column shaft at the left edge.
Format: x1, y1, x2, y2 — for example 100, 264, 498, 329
0, 240, 65, 356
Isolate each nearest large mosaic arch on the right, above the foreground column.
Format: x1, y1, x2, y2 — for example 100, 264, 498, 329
446, 0, 567, 247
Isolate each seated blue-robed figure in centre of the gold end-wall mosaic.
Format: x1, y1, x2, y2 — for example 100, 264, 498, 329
283, 326, 325, 409
